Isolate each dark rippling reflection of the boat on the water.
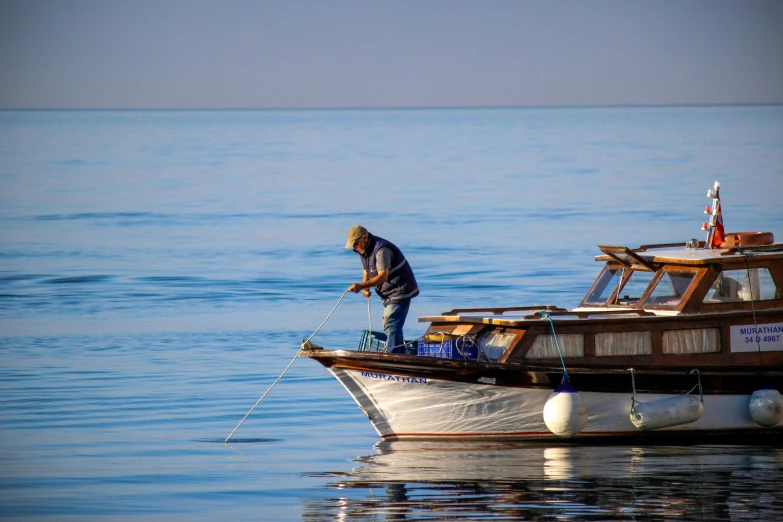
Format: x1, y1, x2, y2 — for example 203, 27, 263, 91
303, 441, 783, 520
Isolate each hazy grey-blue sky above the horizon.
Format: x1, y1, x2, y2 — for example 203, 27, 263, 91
0, 0, 783, 109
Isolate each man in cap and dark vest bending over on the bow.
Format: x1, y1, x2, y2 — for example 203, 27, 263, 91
345, 225, 419, 352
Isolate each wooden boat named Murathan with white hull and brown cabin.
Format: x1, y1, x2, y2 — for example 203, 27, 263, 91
301, 183, 783, 440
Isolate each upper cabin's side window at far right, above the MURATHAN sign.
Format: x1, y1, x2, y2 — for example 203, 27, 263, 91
704, 268, 780, 304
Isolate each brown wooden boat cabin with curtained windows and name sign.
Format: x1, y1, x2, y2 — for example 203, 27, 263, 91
418, 238, 783, 368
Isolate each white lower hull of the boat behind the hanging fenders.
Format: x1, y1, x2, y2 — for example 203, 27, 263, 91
329, 368, 783, 439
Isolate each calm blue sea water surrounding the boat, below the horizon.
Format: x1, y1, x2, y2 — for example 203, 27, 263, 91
0, 106, 783, 520
